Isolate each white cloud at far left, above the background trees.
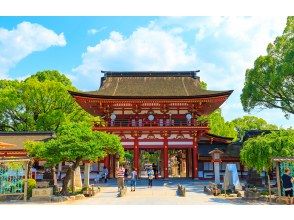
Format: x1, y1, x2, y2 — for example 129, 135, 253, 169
0, 22, 66, 75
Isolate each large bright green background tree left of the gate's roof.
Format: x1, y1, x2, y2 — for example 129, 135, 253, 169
0, 70, 91, 131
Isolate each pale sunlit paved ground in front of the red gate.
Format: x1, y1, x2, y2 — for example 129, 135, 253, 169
62, 179, 268, 205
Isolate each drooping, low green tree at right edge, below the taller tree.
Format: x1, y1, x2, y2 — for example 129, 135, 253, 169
240, 129, 294, 201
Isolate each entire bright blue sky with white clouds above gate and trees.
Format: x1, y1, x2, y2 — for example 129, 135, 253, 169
0, 17, 294, 127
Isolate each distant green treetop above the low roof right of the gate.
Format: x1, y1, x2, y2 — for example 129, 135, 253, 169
230, 116, 278, 139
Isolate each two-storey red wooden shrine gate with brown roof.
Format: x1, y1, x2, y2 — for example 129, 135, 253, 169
70, 71, 233, 178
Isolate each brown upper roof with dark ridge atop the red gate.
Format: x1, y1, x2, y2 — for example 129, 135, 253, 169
71, 71, 233, 97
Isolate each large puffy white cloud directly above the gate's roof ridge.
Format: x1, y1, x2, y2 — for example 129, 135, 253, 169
74, 25, 196, 89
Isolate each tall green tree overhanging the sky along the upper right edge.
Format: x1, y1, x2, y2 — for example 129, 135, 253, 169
241, 17, 294, 118
